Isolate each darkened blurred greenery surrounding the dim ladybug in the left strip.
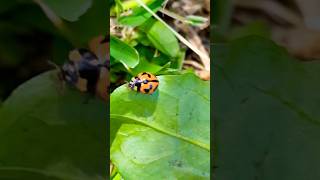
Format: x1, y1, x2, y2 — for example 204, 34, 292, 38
0, 0, 109, 180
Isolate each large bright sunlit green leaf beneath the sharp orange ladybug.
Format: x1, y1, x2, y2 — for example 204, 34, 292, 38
110, 73, 210, 179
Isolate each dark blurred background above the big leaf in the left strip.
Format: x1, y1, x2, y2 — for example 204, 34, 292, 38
0, 0, 109, 101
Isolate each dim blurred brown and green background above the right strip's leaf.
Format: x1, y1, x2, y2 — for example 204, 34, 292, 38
211, 0, 320, 61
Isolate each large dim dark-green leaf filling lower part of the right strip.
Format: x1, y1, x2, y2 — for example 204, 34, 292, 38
213, 36, 320, 180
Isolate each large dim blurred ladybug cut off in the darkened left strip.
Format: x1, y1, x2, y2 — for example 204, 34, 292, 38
56, 35, 110, 100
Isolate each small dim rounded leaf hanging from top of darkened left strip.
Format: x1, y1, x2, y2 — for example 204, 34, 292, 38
42, 0, 92, 21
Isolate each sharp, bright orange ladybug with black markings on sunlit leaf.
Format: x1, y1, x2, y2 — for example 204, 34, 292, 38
128, 72, 159, 94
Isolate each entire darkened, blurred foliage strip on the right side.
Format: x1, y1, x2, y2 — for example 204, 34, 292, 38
211, 0, 320, 180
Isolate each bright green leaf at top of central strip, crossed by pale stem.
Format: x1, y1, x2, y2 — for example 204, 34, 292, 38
118, 0, 164, 27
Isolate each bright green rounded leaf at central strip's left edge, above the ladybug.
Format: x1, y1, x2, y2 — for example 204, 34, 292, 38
110, 36, 139, 68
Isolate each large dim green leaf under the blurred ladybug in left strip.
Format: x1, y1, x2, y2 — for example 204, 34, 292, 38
0, 71, 107, 180
